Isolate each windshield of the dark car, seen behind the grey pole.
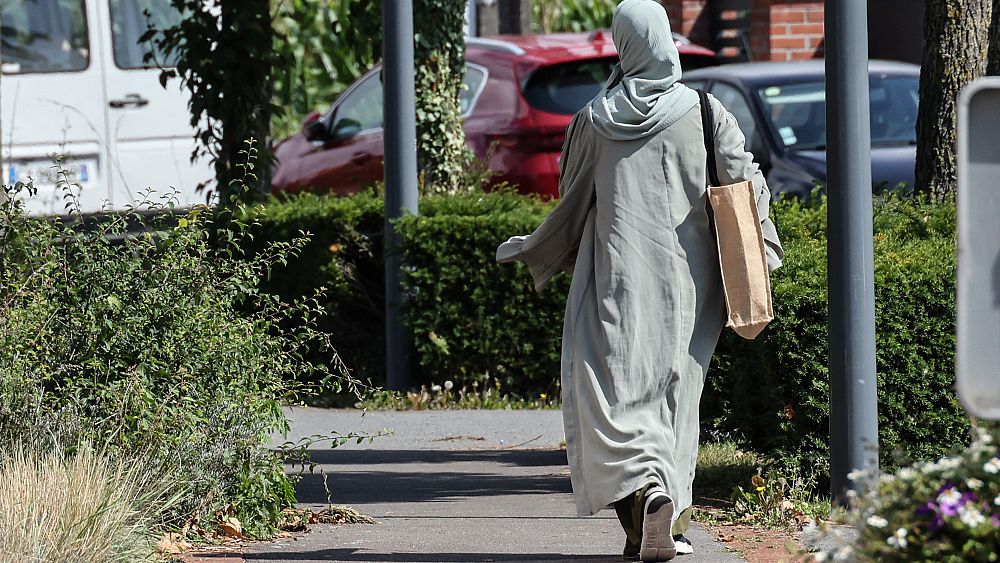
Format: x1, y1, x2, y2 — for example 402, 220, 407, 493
757, 76, 919, 150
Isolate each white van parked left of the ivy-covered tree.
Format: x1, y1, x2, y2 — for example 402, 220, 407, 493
0, 0, 212, 214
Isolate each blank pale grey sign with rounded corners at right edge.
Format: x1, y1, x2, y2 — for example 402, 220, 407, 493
957, 78, 1000, 419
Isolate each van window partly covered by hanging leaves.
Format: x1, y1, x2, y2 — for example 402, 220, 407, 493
111, 0, 181, 69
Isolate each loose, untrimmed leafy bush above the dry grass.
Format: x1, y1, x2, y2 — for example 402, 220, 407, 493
0, 171, 360, 537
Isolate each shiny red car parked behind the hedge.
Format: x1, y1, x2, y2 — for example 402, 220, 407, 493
272, 31, 715, 196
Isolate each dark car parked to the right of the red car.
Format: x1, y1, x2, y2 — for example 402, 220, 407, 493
684, 60, 920, 197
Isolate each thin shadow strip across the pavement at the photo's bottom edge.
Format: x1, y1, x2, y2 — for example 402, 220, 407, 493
243, 548, 620, 563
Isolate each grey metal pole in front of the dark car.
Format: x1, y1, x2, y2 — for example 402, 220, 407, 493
826, 0, 878, 503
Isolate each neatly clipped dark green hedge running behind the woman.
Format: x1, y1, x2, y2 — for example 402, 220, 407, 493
248, 193, 968, 472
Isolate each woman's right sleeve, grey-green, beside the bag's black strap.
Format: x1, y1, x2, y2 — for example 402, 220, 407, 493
708, 94, 785, 271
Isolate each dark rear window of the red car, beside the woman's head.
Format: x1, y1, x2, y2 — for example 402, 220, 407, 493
524, 58, 618, 115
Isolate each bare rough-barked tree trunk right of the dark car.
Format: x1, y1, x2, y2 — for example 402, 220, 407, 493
916, 0, 995, 201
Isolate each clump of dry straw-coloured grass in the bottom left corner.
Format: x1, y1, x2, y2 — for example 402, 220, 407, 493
0, 448, 176, 563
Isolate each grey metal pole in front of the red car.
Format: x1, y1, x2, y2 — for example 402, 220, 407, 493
382, 0, 417, 390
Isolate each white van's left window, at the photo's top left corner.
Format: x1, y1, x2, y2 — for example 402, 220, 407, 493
0, 0, 90, 74
